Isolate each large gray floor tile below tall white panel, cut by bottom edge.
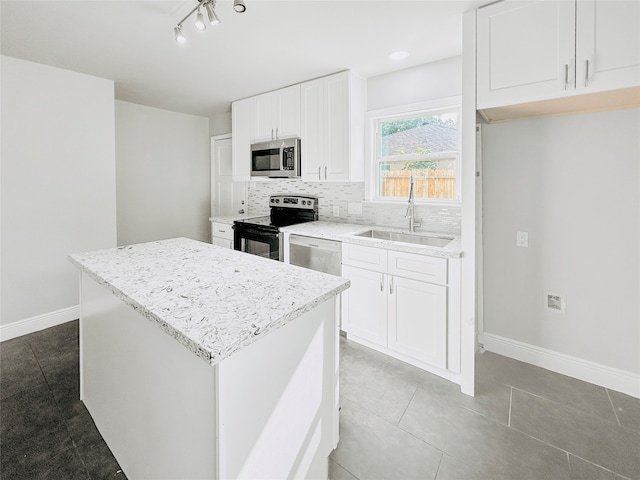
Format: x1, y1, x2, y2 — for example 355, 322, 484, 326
400, 389, 569, 480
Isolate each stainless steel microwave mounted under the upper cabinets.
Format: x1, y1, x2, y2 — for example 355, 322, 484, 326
251, 138, 300, 178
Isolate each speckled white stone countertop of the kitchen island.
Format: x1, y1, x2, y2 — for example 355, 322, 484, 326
69, 238, 349, 365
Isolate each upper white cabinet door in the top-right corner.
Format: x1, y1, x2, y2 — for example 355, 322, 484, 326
576, 0, 640, 90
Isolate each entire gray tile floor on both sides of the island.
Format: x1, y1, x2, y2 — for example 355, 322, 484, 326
0, 321, 640, 480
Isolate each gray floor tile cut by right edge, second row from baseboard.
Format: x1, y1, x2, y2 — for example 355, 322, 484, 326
511, 389, 640, 479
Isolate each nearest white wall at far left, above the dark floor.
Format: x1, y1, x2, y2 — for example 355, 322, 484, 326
0, 56, 116, 326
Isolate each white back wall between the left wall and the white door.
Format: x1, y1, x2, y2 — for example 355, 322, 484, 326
115, 100, 210, 245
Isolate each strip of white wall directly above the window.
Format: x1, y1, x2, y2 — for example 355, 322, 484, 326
367, 57, 462, 110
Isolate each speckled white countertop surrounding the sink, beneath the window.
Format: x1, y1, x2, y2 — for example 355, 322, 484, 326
280, 221, 462, 258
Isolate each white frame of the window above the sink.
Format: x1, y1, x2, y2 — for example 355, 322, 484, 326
365, 96, 462, 205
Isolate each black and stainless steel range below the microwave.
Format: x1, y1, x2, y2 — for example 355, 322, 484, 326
233, 195, 318, 261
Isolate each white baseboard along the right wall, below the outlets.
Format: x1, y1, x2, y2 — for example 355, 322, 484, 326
482, 332, 640, 398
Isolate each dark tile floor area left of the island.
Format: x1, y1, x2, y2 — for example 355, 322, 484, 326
0, 321, 126, 480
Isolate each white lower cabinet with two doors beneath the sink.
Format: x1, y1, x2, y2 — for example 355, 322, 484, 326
342, 243, 447, 370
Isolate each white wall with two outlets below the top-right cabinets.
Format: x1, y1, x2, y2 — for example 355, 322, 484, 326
483, 109, 640, 378
